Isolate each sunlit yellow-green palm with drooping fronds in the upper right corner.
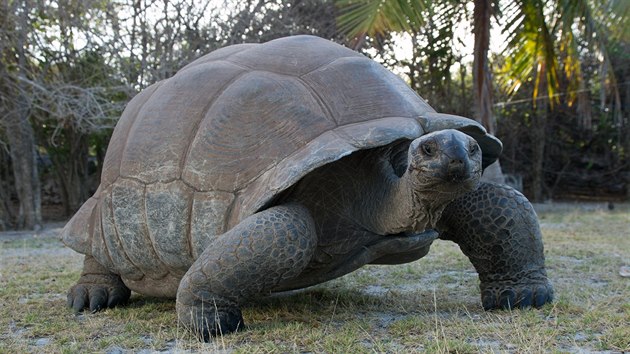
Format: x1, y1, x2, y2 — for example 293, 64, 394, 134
500, 0, 630, 200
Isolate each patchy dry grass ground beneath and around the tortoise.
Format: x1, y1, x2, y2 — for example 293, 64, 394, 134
0, 204, 630, 353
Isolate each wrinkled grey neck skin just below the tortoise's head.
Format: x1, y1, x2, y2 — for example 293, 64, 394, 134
365, 160, 466, 235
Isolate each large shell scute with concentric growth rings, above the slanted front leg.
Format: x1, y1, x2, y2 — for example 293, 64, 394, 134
183, 71, 335, 192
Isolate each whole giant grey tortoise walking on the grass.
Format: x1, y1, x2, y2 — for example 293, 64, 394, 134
62, 36, 553, 340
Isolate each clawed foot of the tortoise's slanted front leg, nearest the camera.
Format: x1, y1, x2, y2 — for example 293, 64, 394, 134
177, 301, 245, 342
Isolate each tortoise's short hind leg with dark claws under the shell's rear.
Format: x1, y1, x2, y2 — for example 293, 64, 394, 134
68, 256, 131, 312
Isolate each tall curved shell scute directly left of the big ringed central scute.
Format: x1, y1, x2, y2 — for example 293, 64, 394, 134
120, 61, 244, 183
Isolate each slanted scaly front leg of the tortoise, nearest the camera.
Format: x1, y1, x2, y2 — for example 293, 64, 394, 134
177, 204, 317, 342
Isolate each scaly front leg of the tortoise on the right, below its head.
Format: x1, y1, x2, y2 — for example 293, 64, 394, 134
438, 183, 553, 310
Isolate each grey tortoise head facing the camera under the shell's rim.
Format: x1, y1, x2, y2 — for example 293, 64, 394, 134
407, 129, 482, 199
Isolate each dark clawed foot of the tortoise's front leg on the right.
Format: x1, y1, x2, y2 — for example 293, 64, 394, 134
481, 282, 553, 310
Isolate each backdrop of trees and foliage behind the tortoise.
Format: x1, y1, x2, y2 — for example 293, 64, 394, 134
0, 0, 630, 229
